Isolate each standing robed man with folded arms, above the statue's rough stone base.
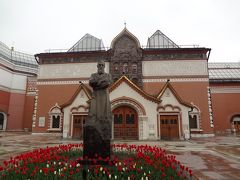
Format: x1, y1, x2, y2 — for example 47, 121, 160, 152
85, 61, 112, 140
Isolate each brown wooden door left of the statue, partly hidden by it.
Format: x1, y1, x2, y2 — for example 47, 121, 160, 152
73, 115, 87, 139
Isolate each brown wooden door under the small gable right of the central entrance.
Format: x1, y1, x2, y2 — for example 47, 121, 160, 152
160, 115, 179, 140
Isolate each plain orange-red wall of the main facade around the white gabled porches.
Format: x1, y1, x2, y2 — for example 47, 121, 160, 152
33, 82, 213, 133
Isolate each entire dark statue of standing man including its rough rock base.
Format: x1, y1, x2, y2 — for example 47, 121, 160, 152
83, 61, 112, 158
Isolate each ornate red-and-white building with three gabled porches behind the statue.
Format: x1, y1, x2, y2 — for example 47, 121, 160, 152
0, 28, 240, 140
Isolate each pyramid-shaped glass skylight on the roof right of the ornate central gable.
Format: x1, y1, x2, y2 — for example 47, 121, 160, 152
147, 30, 179, 48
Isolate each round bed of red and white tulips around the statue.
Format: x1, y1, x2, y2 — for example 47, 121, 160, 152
0, 144, 192, 180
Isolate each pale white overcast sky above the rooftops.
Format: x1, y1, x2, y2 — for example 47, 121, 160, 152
0, 0, 240, 62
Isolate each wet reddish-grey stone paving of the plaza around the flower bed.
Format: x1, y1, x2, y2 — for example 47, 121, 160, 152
0, 132, 240, 180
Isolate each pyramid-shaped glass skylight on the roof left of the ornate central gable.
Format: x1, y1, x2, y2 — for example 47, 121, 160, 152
68, 34, 105, 52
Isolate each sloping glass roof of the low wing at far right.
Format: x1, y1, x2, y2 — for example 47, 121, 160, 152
208, 63, 240, 81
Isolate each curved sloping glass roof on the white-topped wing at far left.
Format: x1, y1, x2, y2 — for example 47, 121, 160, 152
0, 42, 38, 69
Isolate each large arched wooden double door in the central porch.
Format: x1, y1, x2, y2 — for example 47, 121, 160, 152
113, 106, 138, 139
